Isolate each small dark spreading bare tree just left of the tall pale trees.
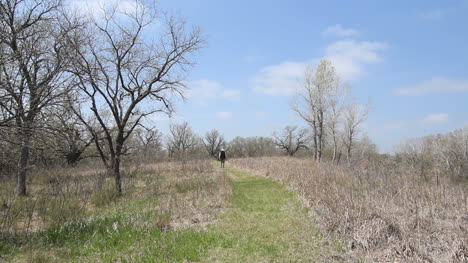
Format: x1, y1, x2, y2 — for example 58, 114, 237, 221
273, 126, 309, 156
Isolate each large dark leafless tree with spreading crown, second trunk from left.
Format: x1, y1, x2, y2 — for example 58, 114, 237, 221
68, 1, 203, 193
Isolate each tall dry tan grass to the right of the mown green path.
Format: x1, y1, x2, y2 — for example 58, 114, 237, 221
230, 157, 468, 262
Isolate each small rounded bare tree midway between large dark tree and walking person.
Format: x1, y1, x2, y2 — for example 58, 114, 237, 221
168, 122, 200, 157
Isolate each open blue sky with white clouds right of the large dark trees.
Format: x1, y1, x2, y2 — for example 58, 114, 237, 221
71, 0, 468, 152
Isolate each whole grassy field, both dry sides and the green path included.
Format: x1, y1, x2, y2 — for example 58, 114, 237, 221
0, 157, 468, 262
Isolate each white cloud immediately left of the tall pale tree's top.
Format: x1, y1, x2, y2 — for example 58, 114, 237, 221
250, 61, 307, 95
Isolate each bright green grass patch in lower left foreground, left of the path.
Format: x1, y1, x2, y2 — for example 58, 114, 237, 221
2, 211, 227, 262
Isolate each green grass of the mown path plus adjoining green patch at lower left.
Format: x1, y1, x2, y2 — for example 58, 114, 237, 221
4, 166, 341, 263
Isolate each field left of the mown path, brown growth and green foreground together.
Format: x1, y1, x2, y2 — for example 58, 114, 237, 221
0, 161, 231, 262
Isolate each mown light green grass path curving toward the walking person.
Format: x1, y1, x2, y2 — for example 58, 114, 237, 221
207, 169, 336, 262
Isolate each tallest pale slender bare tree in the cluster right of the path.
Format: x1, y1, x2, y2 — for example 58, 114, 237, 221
292, 60, 339, 162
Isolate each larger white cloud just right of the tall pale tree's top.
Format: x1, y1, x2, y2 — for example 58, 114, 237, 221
325, 40, 388, 80
